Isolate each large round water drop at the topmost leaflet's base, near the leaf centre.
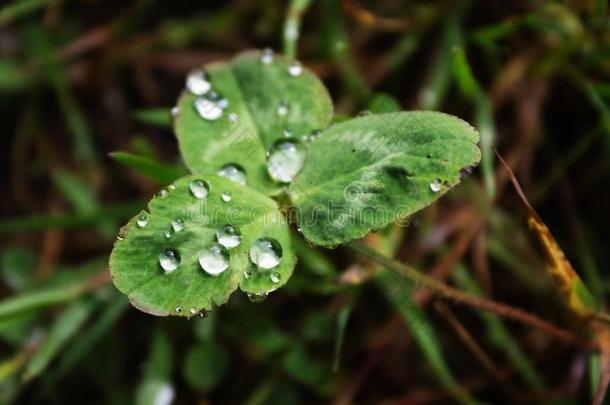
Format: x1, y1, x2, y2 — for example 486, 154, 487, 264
267, 140, 305, 183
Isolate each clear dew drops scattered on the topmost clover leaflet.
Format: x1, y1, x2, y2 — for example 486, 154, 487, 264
172, 49, 321, 184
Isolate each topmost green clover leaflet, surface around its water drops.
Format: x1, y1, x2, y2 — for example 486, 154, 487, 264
174, 51, 333, 194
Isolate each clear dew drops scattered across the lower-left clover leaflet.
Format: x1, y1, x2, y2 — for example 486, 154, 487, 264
127, 179, 282, 315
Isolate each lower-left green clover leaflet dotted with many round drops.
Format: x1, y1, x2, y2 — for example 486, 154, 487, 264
110, 174, 296, 316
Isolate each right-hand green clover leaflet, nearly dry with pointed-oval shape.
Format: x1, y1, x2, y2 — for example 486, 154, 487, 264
289, 111, 481, 247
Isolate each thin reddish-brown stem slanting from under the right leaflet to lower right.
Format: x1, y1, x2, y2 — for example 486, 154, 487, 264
347, 241, 599, 351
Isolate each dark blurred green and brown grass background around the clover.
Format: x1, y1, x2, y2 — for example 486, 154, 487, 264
0, 0, 610, 405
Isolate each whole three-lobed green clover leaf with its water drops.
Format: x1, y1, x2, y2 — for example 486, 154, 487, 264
110, 51, 480, 316
